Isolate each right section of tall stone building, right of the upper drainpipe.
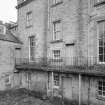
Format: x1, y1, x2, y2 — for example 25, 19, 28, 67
47, 0, 105, 105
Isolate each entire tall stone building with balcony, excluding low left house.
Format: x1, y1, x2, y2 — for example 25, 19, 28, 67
16, 0, 105, 105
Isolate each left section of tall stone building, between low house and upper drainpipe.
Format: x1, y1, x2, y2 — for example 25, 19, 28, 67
16, 0, 48, 93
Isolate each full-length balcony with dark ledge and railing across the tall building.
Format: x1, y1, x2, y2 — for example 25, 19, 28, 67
15, 57, 105, 75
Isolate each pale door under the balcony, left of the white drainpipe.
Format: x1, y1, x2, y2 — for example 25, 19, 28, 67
62, 77, 72, 100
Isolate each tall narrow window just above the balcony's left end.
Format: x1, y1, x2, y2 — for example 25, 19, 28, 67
29, 36, 35, 61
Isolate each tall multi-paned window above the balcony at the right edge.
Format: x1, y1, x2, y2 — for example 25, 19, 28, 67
98, 21, 105, 62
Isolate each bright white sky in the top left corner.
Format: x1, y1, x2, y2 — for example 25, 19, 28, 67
0, 0, 17, 22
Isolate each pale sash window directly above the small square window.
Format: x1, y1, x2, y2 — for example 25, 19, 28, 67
53, 20, 62, 40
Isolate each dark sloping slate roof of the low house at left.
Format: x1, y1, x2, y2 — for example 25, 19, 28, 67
0, 30, 22, 44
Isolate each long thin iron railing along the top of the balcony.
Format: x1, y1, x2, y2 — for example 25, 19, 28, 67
15, 57, 98, 66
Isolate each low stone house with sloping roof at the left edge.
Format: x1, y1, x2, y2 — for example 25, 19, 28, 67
0, 22, 22, 90
